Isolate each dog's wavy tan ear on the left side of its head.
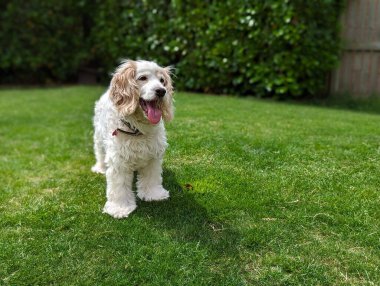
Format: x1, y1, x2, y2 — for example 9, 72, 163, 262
110, 60, 139, 115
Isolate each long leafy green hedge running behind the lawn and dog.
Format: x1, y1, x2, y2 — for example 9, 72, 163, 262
0, 0, 344, 96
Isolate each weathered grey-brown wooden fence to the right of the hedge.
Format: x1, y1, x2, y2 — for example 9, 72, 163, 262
329, 0, 380, 97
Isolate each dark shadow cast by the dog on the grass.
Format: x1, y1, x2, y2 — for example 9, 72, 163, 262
134, 169, 240, 256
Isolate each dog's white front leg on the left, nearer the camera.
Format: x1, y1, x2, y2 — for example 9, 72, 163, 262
103, 166, 136, 218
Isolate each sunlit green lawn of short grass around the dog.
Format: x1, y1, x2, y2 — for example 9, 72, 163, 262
0, 87, 380, 285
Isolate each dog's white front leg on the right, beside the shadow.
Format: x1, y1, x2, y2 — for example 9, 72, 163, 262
137, 159, 169, 201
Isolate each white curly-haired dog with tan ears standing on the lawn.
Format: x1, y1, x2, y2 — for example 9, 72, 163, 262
91, 60, 173, 218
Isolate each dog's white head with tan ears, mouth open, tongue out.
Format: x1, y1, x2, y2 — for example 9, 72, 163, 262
110, 60, 173, 124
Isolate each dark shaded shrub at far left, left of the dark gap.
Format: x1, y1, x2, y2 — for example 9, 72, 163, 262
0, 0, 91, 84
